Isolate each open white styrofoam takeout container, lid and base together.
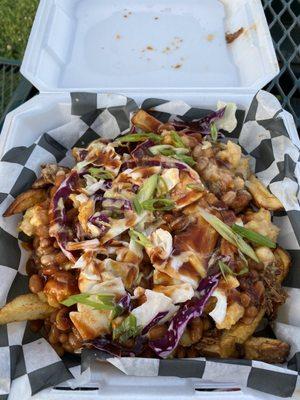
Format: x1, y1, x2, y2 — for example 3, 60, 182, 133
0, 0, 298, 400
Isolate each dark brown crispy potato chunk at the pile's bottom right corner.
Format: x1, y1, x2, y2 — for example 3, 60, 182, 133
244, 337, 290, 364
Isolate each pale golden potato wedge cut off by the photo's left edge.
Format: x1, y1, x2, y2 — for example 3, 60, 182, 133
0, 293, 55, 325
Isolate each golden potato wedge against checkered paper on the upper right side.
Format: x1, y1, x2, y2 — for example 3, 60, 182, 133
247, 175, 283, 211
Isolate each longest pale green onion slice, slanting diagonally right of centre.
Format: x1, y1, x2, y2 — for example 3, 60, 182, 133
199, 208, 259, 263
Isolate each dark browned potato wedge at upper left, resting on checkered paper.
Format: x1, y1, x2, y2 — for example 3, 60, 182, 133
3, 189, 47, 217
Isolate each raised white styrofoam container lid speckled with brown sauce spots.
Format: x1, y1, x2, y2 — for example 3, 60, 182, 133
21, 0, 278, 98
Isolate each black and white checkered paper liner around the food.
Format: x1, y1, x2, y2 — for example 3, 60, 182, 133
0, 91, 300, 400
